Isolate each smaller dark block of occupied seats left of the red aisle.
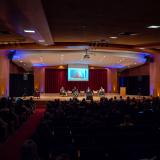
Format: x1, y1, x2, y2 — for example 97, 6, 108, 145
0, 97, 35, 143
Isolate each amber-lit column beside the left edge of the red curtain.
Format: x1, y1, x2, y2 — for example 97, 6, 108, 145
34, 67, 45, 92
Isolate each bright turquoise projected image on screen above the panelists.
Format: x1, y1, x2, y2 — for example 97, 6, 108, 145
68, 64, 88, 81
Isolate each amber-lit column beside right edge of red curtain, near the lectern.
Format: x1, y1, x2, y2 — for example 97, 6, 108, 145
107, 68, 118, 93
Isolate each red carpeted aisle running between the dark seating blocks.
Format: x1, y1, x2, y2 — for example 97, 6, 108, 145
0, 106, 45, 160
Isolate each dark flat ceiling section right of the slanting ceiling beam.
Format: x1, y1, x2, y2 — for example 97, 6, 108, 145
42, 0, 160, 45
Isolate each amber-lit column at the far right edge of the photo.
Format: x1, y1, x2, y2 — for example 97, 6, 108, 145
149, 54, 160, 96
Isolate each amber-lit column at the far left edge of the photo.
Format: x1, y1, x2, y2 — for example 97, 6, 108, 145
0, 50, 9, 96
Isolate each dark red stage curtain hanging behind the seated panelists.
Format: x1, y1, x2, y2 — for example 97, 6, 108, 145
45, 69, 107, 93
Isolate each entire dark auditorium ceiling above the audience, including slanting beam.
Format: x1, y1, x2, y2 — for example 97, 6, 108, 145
0, 0, 160, 45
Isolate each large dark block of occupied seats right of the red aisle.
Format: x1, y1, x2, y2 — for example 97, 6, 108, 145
27, 98, 160, 160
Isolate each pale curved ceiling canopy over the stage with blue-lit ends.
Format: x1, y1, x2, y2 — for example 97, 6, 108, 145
13, 49, 146, 70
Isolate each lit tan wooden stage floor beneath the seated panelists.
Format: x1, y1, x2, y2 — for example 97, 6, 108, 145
26, 93, 149, 101
